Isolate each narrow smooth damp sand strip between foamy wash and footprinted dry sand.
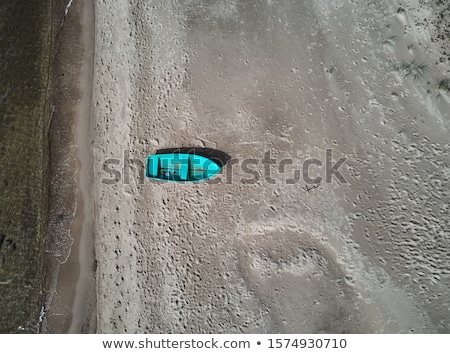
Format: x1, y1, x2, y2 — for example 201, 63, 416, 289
69, 0, 96, 333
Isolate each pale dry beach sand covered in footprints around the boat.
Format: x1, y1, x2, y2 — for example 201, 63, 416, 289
86, 0, 450, 333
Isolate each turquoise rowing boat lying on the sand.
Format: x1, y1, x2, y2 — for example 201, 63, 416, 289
145, 153, 221, 183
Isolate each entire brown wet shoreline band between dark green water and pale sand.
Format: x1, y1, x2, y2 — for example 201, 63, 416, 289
43, 0, 95, 333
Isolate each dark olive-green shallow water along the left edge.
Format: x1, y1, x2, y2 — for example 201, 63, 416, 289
0, 0, 65, 333
